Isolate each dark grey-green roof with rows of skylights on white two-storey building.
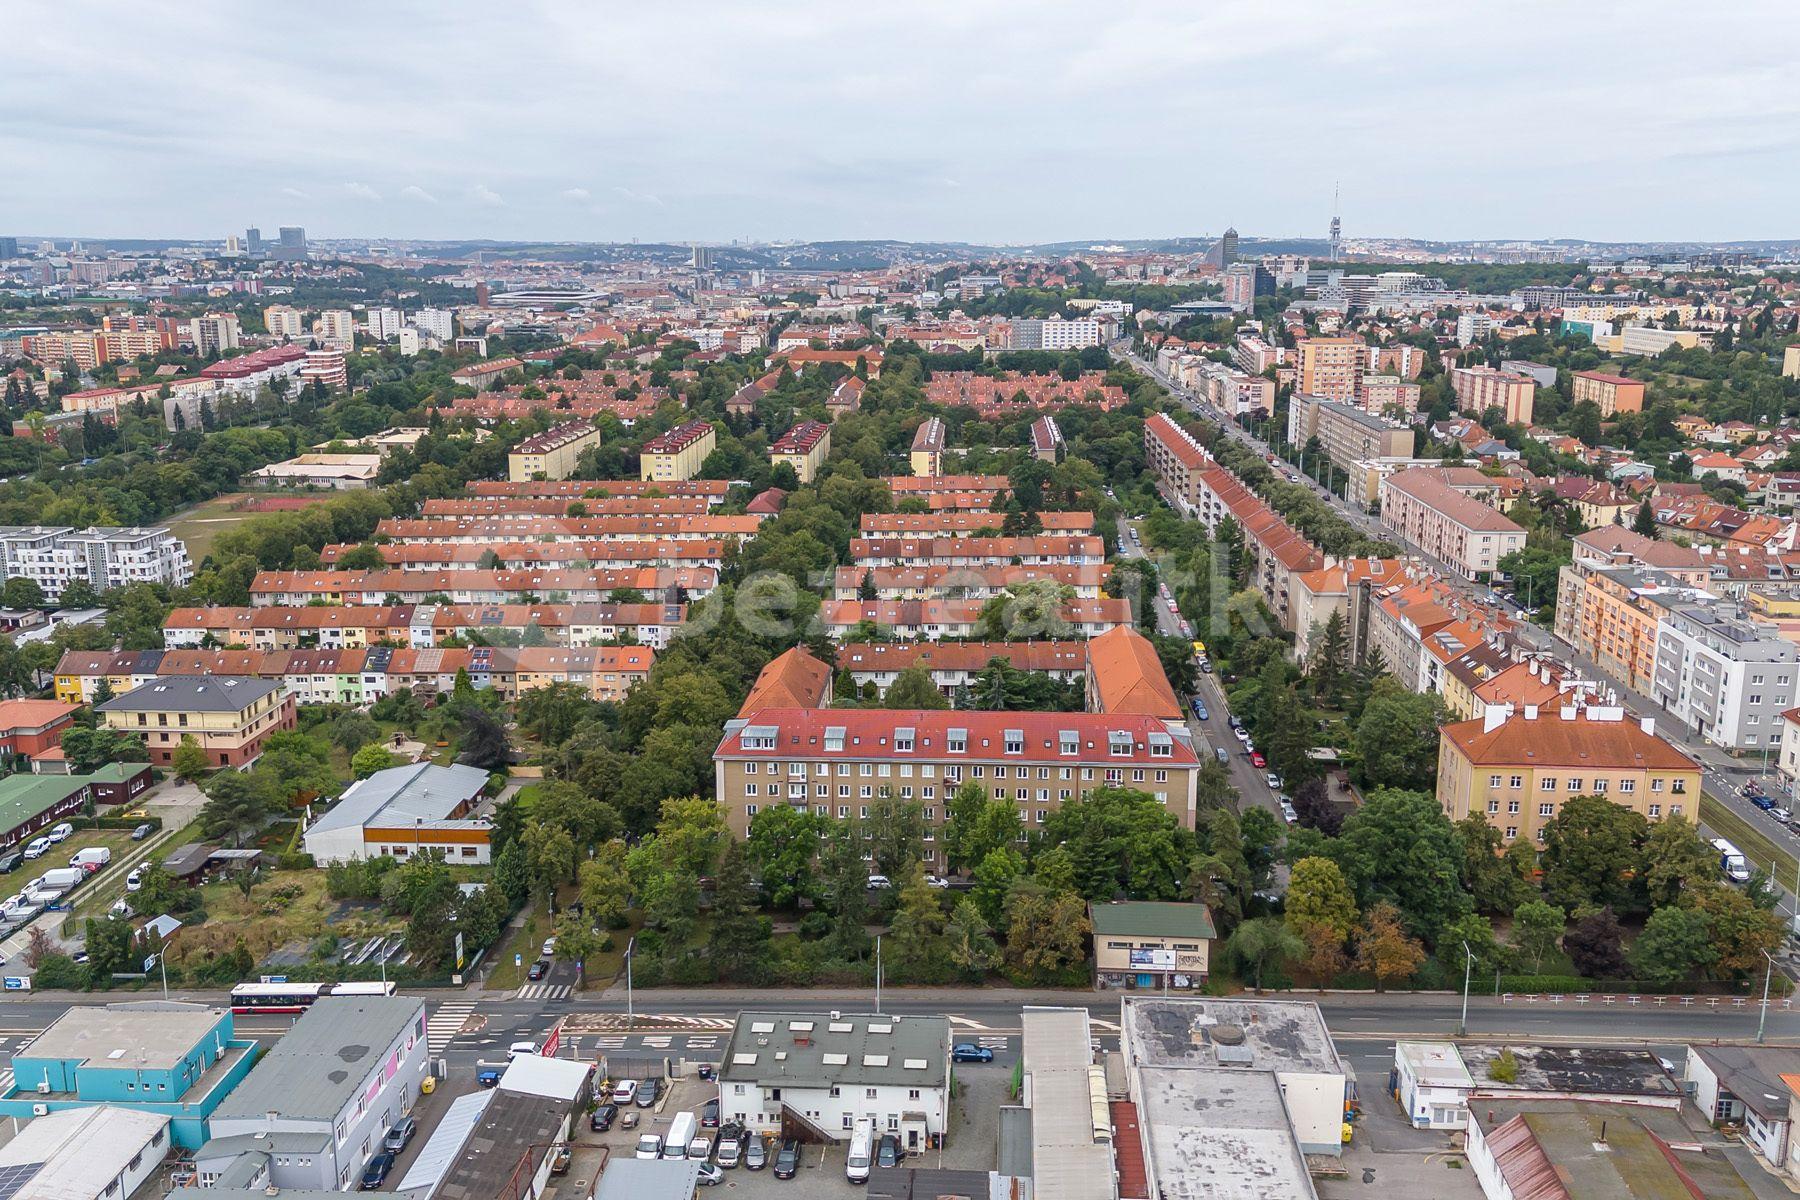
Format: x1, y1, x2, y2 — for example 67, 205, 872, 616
718, 1013, 950, 1087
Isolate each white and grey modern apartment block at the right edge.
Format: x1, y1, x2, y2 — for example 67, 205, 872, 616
1651, 604, 1800, 754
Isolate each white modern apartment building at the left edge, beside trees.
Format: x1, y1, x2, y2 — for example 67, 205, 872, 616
0, 525, 194, 603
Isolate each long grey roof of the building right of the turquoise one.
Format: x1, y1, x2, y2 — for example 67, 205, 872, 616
212, 995, 425, 1123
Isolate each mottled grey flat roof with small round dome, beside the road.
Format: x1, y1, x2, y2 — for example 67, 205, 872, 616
1121, 997, 1348, 1074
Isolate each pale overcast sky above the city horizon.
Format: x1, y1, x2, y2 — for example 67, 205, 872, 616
10, 0, 1800, 245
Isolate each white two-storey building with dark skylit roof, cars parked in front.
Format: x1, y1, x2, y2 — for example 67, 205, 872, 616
718, 1013, 950, 1151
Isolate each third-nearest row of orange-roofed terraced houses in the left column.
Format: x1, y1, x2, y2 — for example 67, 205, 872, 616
250, 567, 718, 604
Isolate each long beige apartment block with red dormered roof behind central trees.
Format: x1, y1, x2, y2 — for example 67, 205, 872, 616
713, 709, 1199, 852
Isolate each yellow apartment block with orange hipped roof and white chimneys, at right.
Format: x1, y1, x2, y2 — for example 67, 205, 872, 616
1438, 705, 1699, 842
